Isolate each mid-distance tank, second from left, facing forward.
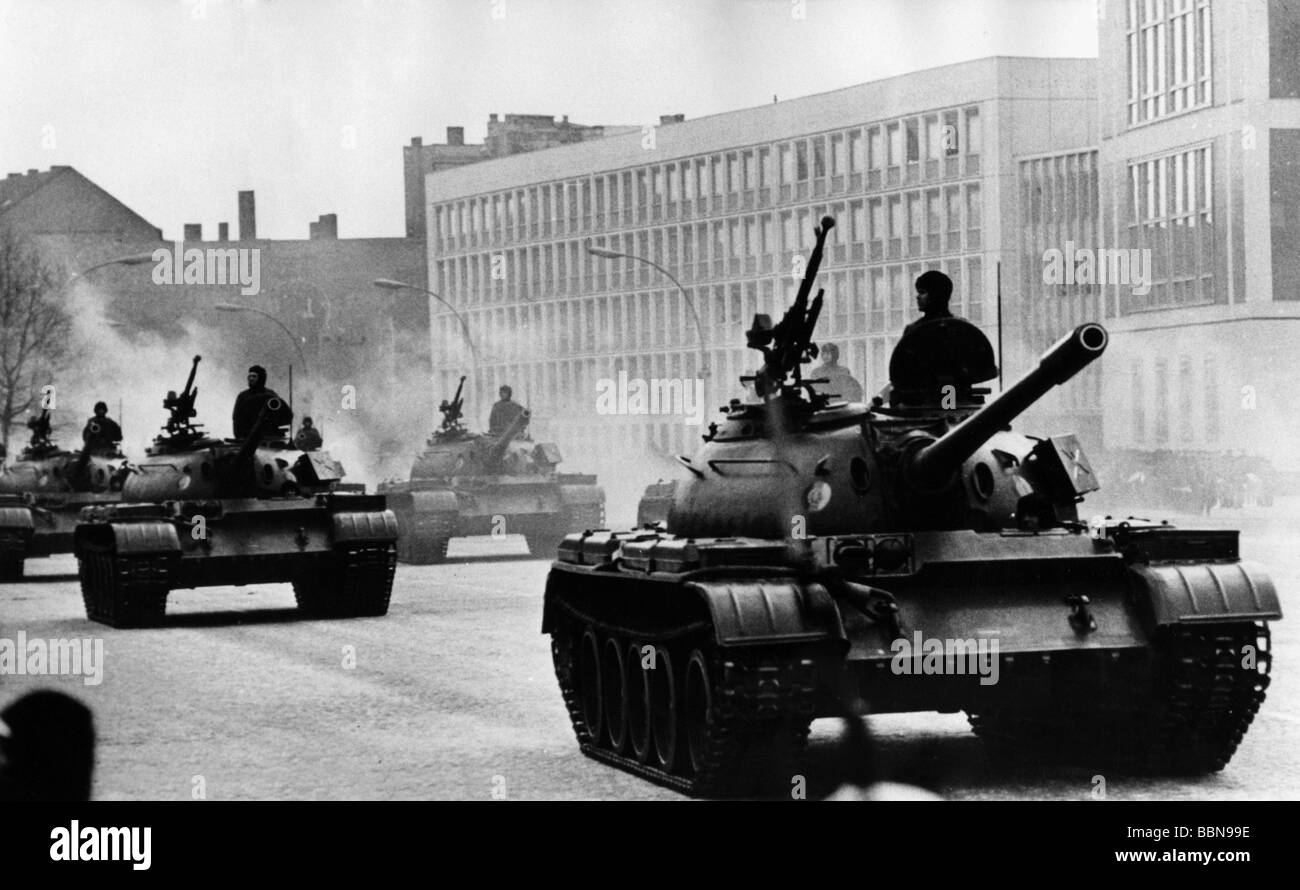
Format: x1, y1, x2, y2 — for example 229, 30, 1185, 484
74, 356, 397, 628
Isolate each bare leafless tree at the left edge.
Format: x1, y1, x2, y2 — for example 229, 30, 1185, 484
0, 226, 72, 451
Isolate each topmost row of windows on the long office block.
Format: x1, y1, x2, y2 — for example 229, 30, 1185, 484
430, 105, 983, 251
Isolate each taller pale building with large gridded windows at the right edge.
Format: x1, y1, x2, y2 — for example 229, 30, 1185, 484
1097, 0, 1300, 469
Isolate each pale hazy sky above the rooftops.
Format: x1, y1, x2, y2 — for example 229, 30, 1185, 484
0, 0, 1097, 239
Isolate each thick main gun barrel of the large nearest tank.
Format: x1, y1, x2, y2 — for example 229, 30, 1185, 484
906, 322, 1108, 489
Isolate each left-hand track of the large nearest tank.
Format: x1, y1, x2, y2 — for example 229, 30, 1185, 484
551, 600, 816, 796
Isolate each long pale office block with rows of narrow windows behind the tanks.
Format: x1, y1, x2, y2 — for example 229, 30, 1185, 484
425, 57, 1099, 460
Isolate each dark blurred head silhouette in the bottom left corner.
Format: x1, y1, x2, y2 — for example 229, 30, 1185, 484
0, 690, 95, 802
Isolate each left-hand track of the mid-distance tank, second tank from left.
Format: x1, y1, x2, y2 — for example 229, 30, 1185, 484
77, 544, 172, 628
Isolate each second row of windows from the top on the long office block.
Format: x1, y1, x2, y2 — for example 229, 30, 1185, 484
433, 183, 983, 305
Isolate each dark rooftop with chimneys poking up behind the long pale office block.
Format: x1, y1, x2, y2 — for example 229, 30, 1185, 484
402, 114, 640, 238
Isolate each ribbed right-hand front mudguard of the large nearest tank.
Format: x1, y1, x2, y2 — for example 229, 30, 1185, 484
1130, 561, 1282, 628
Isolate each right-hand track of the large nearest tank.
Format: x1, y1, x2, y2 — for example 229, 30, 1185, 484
970, 622, 1273, 774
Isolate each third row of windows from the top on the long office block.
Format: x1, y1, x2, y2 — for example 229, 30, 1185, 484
433, 256, 985, 366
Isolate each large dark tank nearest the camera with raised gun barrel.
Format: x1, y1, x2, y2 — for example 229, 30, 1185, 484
542, 218, 1282, 795
